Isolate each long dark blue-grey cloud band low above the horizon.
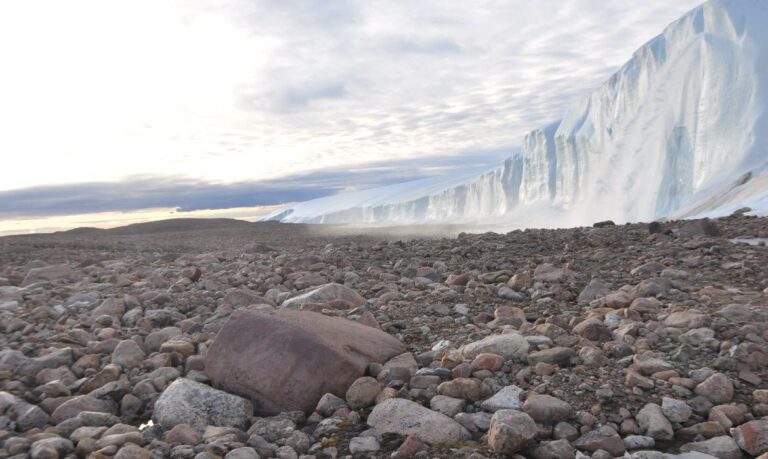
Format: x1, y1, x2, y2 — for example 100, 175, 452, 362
0, 149, 513, 220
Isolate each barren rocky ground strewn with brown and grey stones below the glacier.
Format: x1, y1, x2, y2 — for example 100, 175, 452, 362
0, 216, 768, 459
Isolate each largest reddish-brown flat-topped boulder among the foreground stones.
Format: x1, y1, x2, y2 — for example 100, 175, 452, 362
205, 309, 405, 415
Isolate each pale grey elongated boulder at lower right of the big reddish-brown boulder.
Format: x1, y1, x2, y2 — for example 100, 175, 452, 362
368, 398, 470, 444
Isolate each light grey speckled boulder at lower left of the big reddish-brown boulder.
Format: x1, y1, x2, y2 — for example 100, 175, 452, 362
152, 378, 253, 430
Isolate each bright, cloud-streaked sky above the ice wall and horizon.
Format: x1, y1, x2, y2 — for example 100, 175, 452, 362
0, 0, 700, 230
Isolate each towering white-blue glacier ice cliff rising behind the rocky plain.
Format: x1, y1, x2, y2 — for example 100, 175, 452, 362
268, 0, 768, 226
